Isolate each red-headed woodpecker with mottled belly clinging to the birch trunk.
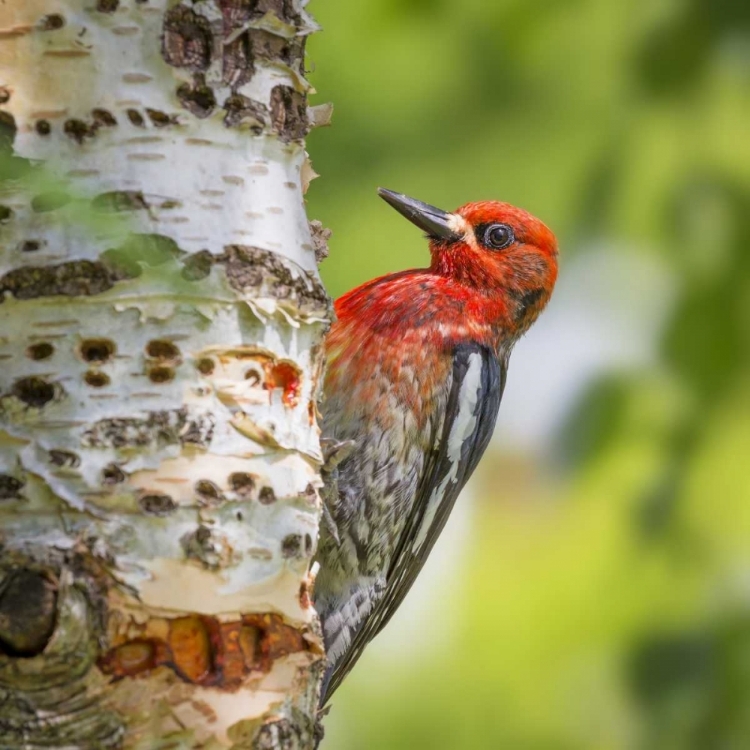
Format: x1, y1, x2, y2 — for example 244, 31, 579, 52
313, 188, 558, 709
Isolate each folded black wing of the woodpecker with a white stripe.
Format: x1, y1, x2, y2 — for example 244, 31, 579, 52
321, 344, 507, 705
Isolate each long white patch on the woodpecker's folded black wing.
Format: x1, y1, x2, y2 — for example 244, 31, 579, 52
412, 352, 482, 552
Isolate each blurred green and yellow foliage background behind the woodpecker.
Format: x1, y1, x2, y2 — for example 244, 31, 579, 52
308, 0, 750, 750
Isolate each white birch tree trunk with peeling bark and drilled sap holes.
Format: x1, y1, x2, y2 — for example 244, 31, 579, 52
0, 0, 329, 750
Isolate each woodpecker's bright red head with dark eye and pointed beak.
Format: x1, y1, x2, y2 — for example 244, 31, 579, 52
378, 188, 557, 323
